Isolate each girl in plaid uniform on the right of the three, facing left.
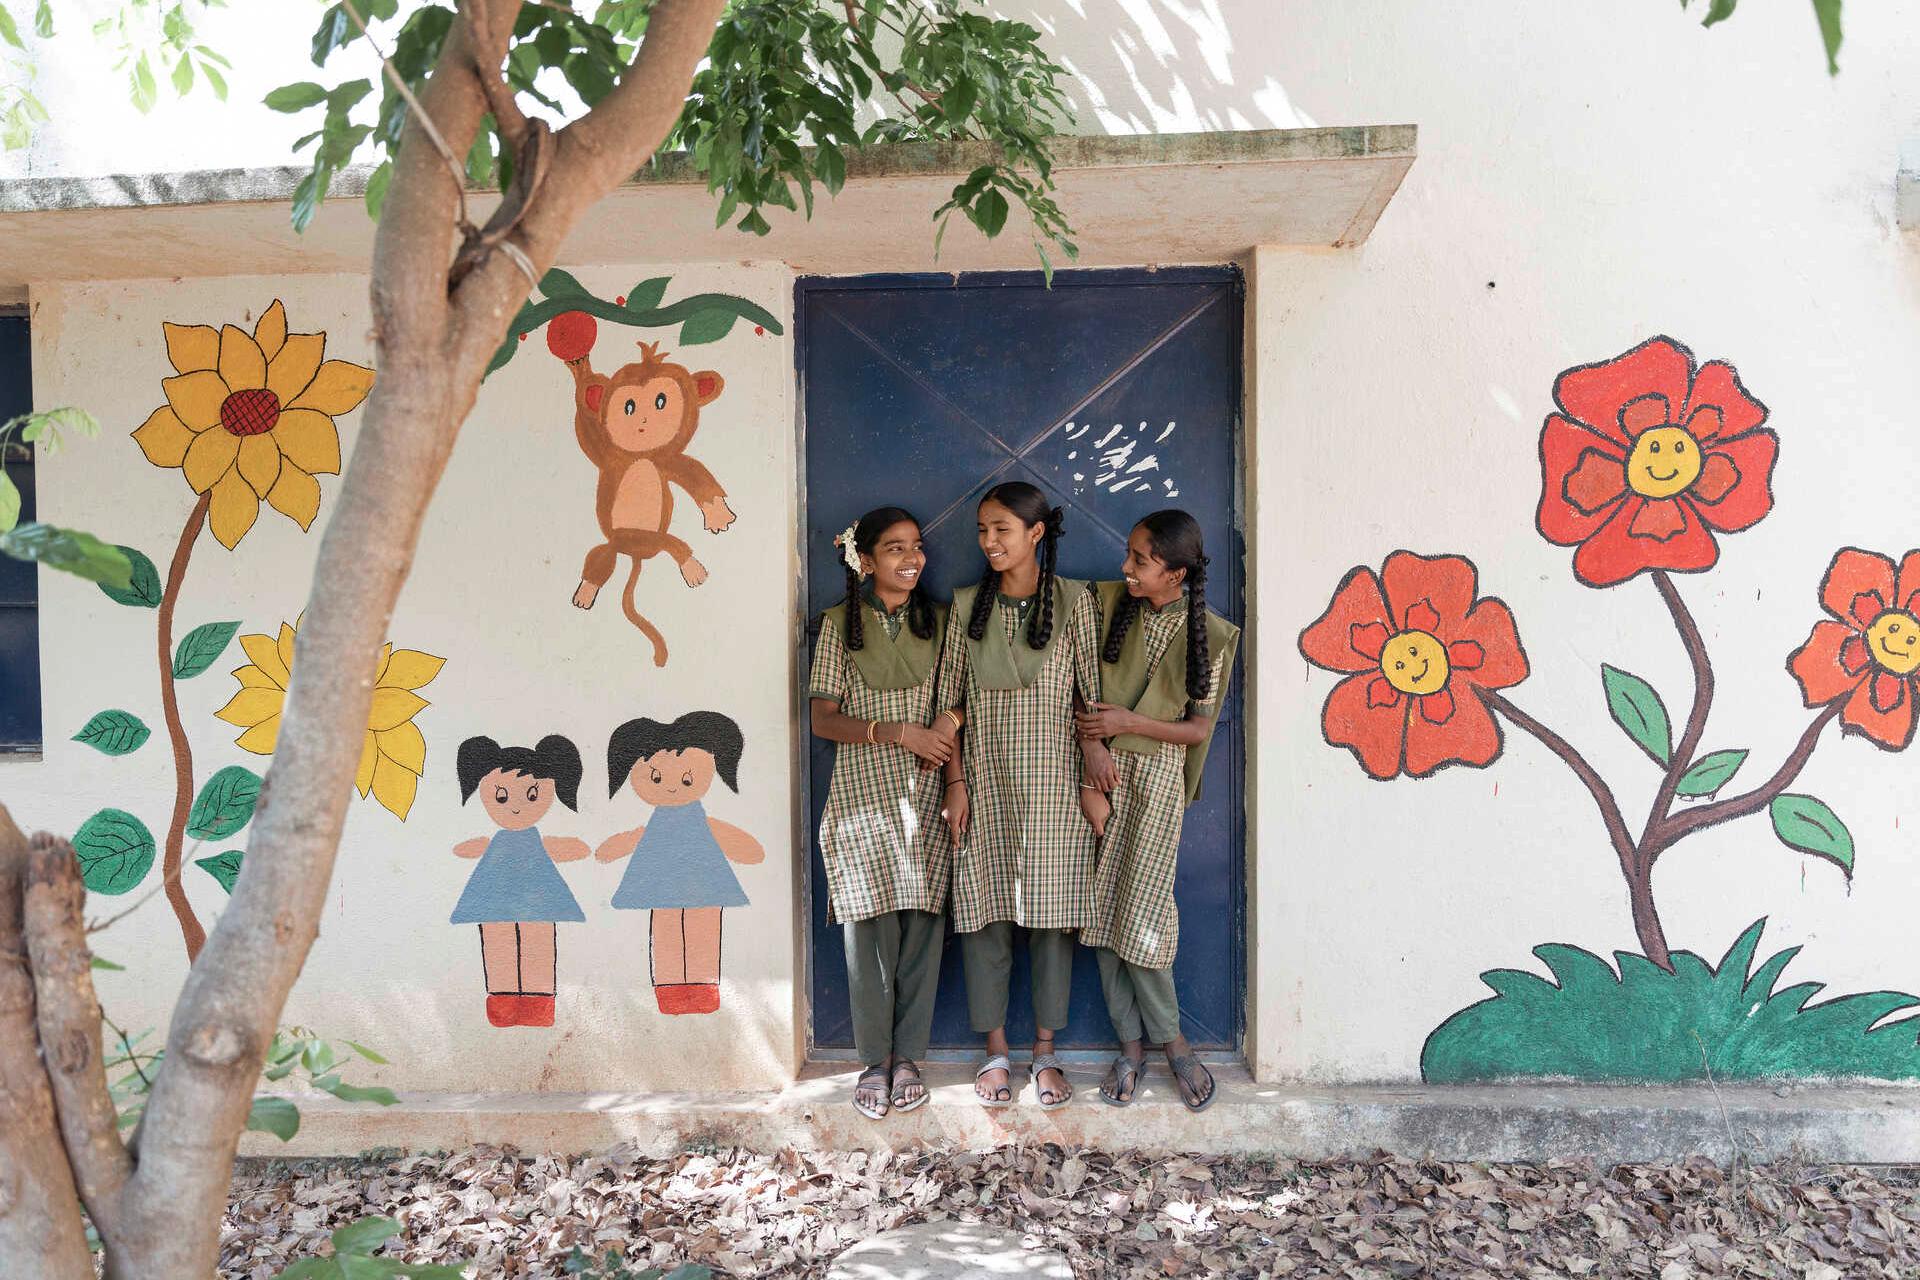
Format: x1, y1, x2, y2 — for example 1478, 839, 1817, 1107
1077, 510, 1240, 1111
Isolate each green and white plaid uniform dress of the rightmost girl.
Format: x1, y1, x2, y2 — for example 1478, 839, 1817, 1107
1081, 595, 1229, 969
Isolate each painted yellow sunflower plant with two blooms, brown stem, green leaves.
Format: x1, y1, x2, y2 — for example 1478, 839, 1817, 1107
73, 299, 428, 958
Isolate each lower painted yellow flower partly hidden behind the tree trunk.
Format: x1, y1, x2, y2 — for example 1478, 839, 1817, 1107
215, 622, 447, 819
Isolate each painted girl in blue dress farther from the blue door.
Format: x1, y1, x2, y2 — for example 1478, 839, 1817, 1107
451, 733, 591, 1027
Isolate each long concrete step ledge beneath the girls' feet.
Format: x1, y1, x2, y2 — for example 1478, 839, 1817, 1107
240, 1063, 1920, 1163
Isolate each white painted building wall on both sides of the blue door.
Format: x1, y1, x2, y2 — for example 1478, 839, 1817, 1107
0, 0, 1920, 1088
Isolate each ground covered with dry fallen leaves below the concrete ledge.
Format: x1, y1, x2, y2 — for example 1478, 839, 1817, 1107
221, 1146, 1920, 1280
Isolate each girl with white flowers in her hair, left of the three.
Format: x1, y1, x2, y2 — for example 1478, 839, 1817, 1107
808, 507, 964, 1121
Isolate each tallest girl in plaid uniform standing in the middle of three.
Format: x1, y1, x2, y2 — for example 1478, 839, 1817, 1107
941, 480, 1098, 1111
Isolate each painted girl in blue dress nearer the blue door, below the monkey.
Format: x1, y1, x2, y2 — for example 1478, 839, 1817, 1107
595, 712, 766, 1013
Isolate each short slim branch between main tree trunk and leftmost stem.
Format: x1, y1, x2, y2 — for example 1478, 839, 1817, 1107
25, 831, 132, 1236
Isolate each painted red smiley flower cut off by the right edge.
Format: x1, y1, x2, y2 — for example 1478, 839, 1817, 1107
1788, 547, 1920, 750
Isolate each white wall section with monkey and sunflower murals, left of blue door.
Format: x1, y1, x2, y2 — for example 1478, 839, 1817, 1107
16, 267, 797, 1092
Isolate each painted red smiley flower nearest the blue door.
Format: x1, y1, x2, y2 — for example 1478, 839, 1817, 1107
1300, 551, 1526, 779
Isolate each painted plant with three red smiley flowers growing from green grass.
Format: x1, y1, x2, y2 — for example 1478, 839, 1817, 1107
1300, 336, 1920, 1082
